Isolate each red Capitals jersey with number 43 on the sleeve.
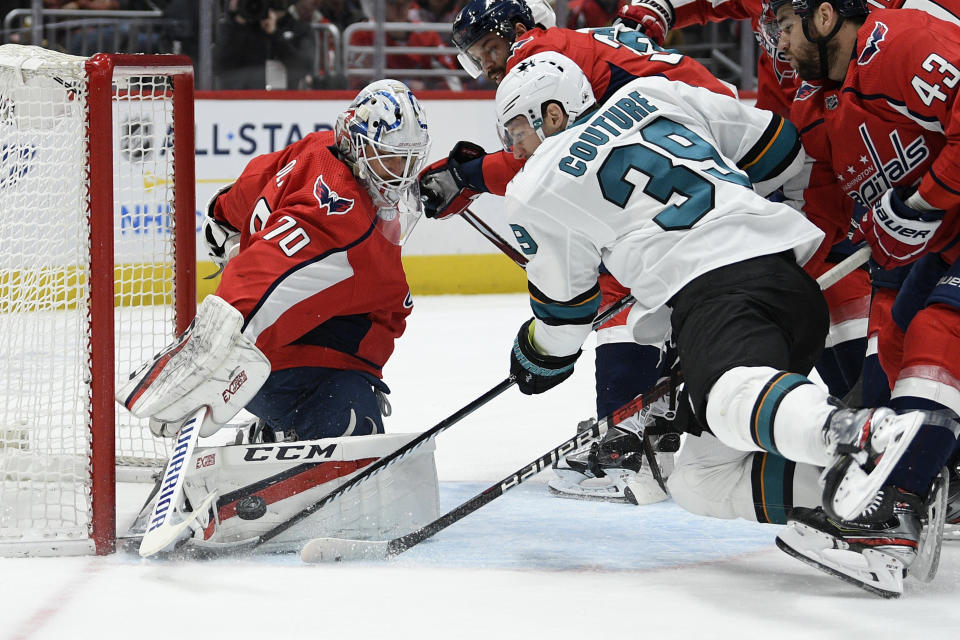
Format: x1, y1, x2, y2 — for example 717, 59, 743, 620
791, 9, 960, 255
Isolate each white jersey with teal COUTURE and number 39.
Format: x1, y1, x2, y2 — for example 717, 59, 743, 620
506, 78, 823, 355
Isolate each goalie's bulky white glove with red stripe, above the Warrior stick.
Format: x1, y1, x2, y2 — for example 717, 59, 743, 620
116, 296, 270, 437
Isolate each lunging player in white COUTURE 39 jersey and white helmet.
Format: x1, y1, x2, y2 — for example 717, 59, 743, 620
497, 53, 924, 580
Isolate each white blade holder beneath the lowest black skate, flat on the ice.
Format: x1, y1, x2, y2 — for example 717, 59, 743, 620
776, 523, 903, 598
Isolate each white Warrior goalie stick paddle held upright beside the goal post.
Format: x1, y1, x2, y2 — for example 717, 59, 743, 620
140, 406, 209, 558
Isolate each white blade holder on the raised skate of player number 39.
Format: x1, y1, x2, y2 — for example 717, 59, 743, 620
823, 411, 924, 520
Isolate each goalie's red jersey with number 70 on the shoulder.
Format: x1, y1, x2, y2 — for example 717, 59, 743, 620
214, 131, 413, 377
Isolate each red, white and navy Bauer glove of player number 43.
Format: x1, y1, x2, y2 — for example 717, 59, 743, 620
849, 188, 944, 269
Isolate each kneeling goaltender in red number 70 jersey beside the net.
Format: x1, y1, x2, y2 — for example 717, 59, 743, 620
117, 80, 436, 555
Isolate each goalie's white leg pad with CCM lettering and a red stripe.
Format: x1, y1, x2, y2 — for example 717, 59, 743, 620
129, 434, 439, 552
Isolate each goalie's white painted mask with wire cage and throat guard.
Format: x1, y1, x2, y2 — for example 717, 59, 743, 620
334, 80, 430, 244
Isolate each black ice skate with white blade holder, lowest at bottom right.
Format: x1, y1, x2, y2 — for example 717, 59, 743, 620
777, 485, 924, 598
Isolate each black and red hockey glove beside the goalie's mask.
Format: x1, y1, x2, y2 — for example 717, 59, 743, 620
419, 140, 487, 220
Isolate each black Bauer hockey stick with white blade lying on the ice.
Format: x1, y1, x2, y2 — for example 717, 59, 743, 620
300, 380, 671, 562
